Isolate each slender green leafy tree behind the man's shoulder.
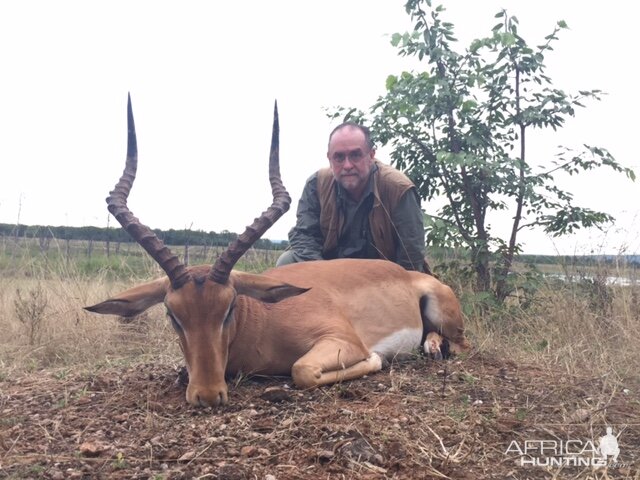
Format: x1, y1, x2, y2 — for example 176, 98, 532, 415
333, 0, 635, 302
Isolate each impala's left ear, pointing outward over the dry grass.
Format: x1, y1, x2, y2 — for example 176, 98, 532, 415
84, 277, 169, 317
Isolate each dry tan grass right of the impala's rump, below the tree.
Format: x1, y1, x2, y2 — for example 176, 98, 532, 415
480, 272, 640, 380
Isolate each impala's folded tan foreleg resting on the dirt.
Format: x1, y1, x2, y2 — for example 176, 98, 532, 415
291, 339, 382, 388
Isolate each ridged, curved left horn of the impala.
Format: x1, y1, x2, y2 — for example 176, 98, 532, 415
107, 94, 191, 290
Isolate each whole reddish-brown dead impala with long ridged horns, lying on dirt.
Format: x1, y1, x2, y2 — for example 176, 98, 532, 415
86, 98, 469, 406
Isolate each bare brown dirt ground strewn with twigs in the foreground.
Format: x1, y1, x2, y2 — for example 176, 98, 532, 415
0, 354, 640, 480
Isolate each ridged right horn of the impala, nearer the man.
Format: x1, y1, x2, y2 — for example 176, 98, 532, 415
209, 102, 291, 284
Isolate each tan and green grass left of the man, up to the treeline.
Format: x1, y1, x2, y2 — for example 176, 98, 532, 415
0, 239, 279, 379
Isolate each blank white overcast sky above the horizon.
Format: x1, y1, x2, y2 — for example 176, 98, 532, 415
0, 0, 640, 254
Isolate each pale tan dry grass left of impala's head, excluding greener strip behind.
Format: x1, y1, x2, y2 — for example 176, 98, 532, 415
0, 268, 179, 378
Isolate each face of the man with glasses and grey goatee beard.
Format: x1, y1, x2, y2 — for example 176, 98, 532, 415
327, 127, 376, 200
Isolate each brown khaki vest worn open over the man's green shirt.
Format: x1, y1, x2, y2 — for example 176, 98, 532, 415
318, 160, 414, 261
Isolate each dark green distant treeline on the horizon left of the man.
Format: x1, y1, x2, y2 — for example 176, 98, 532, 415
0, 223, 286, 250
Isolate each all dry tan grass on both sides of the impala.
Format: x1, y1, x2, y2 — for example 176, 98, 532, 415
0, 252, 640, 379
